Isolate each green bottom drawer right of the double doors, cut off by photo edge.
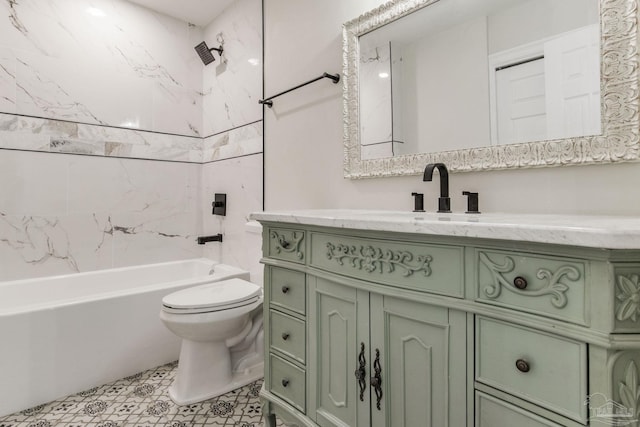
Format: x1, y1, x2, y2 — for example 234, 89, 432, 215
475, 392, 562, 427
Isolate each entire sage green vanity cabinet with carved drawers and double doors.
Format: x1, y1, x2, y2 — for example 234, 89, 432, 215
258, 217, 640, 427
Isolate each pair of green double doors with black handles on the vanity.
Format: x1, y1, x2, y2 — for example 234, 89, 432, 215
308, 277, 466, 427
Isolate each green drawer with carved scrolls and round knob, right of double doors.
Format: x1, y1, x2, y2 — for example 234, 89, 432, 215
475, 249, 587, 325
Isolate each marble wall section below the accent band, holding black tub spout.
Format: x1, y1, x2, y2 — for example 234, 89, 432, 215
201, 153, 262, 283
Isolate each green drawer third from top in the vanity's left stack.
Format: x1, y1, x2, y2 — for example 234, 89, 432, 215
269, 310, 306, 364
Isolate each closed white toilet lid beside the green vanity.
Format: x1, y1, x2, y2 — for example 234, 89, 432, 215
162, 278, 262, 312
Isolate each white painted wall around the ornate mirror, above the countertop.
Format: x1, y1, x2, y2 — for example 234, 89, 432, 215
264, 0, 640, 215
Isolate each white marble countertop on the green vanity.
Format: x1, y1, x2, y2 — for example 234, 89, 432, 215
250, 209, 640, 249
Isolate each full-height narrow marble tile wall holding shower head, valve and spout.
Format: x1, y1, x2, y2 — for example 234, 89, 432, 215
201, 0, 263, 283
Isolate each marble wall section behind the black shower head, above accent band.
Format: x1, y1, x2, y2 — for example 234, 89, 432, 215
203, 0, 262, 137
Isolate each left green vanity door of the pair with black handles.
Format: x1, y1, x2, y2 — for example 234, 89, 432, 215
309, 278, 370, 427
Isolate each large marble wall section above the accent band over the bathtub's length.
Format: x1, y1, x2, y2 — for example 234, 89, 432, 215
0, 0, 202, 136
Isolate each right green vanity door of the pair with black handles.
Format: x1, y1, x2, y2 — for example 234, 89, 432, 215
370, 294, 467, 427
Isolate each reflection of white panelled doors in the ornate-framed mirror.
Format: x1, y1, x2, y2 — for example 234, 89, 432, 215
489, 25, 601, 144
